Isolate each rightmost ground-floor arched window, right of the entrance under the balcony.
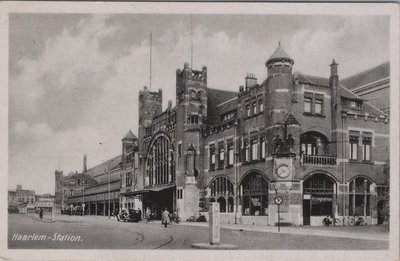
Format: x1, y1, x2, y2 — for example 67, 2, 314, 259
349, 177, 372, 216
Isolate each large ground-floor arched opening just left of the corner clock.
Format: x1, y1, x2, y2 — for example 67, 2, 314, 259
240, 171, 268, 216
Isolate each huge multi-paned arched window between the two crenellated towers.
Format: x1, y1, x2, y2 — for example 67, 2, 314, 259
146, 136, 175, 186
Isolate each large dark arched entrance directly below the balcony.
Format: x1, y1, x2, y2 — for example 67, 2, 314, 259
303, 173, 336, 225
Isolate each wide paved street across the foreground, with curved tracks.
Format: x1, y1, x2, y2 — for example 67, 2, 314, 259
8, 214, 388, 250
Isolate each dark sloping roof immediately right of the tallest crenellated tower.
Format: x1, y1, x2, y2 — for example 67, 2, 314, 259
207, 88, 238, 125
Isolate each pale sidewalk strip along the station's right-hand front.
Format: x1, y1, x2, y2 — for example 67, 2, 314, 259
177, 222, 389, 241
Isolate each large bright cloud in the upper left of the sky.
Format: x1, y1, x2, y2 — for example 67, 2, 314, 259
10, 16, 117, 129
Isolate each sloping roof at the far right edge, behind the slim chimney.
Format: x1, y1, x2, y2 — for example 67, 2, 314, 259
340, 62, 390, 89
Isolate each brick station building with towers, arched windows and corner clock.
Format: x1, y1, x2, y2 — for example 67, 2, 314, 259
57, 43, 390, 226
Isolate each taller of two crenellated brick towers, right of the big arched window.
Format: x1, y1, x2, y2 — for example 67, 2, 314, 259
176, 63, 207, 217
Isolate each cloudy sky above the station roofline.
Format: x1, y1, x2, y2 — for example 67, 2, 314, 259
8, 14, 390, 194
